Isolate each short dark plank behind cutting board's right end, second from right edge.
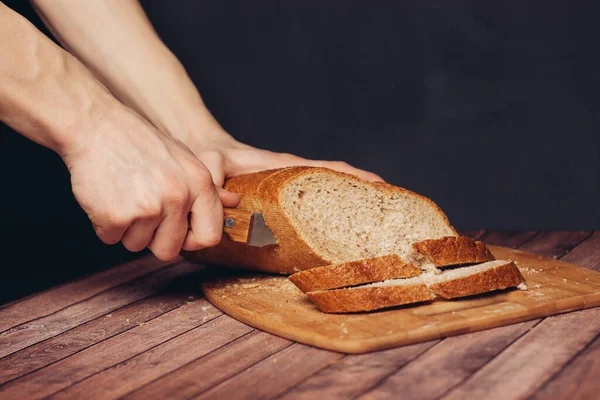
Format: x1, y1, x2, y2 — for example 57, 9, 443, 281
519, 231, 600, 259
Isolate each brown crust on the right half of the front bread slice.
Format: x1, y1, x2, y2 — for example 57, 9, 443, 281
429, 261, 525, 299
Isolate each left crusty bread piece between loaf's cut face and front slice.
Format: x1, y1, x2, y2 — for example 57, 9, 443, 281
290, 254, 421, 292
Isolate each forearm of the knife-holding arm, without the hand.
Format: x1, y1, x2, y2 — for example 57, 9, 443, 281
0, 3, 123, 154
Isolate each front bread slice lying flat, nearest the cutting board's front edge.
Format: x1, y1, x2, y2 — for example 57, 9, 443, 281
307, 260, 525, 313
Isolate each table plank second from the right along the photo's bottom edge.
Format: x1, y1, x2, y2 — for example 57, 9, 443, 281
443, 308, 600, 400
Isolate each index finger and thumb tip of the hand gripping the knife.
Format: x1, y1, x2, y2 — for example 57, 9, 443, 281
183, 186, 225, 251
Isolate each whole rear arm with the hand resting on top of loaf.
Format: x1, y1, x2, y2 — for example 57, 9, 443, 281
33, 0, 381, 185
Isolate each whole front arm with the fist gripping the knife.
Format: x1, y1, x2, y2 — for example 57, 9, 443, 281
0, 2, 238, 259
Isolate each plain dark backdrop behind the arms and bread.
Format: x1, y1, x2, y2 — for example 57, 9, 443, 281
0, 0, 600, 303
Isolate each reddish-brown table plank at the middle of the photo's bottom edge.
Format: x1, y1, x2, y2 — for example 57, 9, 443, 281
282, 340, 440, 400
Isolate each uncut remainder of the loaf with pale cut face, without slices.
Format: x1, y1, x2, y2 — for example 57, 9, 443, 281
183, 167, 457, 273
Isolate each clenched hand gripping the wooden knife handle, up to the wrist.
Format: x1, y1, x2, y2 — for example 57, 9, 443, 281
61, 108, 239, 260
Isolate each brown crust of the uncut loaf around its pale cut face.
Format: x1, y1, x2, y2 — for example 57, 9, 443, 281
182, 167, 455, 274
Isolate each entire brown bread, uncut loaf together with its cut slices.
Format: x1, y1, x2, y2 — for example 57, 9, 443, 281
184, 167, 523, 313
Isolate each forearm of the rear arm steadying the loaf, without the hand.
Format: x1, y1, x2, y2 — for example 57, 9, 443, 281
32, 0, 231, 143
